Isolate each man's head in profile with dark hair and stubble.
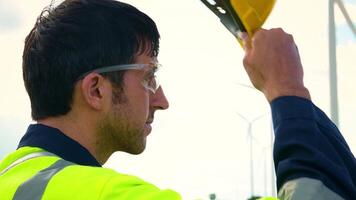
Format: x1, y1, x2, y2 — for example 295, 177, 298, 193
23, 0, 168, 156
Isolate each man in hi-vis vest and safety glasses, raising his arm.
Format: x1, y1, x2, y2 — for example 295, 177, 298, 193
0, 0, 356, 200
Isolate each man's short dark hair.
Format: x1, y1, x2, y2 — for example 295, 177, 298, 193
22, 0, 160, 120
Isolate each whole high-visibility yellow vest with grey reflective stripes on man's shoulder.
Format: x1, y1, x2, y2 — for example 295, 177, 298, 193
0, 147, 181, 200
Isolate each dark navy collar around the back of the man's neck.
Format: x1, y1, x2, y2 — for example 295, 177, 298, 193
18, 124, 101, 167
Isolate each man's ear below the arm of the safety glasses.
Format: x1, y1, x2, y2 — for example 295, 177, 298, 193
80, 73, 111, 110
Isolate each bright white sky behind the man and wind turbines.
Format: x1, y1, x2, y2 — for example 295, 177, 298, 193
0, 0, 356, 199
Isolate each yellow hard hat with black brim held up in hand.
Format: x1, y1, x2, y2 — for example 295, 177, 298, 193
201, 0, 276, 44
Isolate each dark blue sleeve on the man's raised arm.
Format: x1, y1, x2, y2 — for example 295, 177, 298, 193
271, 96, 356, 199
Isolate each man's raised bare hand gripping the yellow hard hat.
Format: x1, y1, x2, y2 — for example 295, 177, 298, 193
240, 28, 310, 101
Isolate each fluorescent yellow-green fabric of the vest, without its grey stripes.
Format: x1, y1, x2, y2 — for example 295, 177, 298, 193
0, 147, 181, 200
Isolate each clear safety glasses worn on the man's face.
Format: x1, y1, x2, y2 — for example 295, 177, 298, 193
77, 63, 162, 93
